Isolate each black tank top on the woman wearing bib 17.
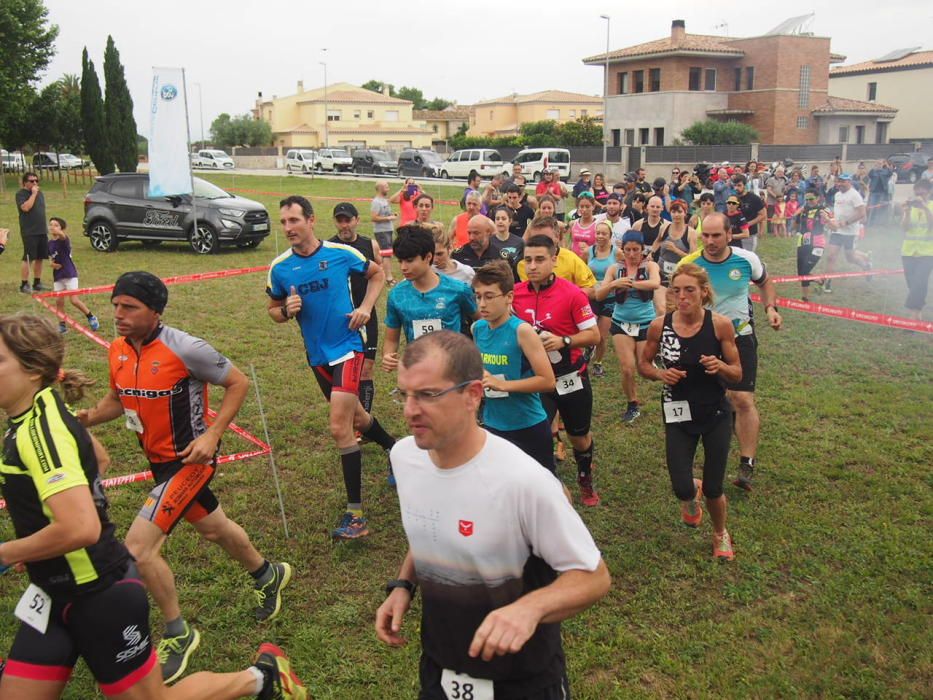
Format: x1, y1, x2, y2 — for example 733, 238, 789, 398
659, 309, 729, 430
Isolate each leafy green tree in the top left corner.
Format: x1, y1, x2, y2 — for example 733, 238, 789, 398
0, 0, 58, 147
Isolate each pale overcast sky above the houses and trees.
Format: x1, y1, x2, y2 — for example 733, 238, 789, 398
42, 0, 933, 140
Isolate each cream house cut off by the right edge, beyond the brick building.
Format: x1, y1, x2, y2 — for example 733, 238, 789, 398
829, 49, 933, 141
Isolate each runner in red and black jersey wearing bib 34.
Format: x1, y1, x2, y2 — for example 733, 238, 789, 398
512, 235, 599, 506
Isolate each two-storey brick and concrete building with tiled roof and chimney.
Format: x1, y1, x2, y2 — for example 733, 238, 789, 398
583, 20, 896, 146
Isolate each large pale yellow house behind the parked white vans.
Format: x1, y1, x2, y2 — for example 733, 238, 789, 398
253, 80, 434, 151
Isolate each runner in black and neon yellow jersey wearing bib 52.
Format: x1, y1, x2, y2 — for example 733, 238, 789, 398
0, 314, 307, 700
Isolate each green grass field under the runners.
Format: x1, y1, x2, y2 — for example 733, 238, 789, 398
0, 175, 933, 700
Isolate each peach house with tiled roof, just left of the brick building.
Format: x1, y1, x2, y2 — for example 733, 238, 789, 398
467, 90, 603, 136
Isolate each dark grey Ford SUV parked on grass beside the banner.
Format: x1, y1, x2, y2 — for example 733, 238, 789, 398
84, 173, 269, 254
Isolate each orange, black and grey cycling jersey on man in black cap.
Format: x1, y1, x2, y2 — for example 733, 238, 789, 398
110, 325, 233, 464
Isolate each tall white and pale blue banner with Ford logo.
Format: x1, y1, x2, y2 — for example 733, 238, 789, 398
149, 68, 192, 197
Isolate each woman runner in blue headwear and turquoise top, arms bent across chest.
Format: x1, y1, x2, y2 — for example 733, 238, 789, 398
596, 231, 661, 425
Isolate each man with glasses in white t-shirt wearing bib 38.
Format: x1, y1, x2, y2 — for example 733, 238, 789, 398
376, 331, 610, 700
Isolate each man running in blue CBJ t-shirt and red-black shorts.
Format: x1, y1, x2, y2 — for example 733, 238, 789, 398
266, 195, 396, 540
